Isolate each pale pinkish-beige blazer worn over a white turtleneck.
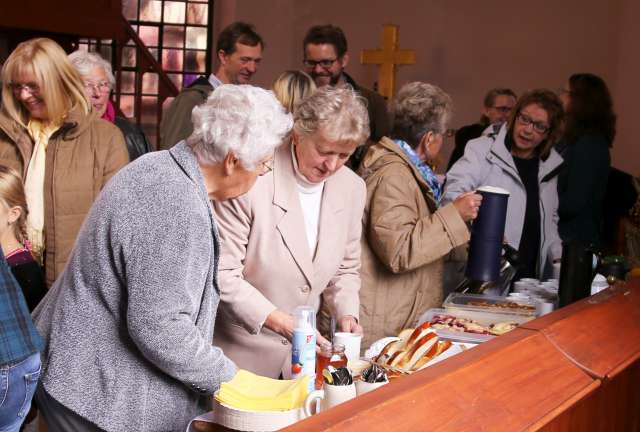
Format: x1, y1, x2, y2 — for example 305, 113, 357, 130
213, 144, 366, 378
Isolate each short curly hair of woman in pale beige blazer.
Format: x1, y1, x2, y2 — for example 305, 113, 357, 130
293, 85, 370, 145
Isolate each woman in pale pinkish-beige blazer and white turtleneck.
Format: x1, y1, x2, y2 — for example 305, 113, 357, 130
214, 86, 369, 378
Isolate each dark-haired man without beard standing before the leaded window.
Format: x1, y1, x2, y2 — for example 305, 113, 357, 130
158, 21, 264, 150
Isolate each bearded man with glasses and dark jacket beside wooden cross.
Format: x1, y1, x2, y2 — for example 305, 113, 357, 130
302, 24, 390, 170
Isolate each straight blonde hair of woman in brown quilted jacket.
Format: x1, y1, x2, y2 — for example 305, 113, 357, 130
2, 38, 91, 127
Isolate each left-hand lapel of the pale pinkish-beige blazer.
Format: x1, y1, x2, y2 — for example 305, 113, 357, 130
273, 143, 313, 286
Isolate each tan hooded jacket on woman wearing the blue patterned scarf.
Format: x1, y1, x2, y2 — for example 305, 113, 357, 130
360, 137, 469, 348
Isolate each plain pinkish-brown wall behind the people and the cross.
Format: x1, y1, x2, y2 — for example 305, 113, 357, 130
216, 0, 640, 175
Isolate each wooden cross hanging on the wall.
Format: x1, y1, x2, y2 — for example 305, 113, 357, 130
360, 25, 416, 99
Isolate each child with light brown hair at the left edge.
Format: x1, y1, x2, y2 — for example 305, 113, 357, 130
0, 165, 47, 312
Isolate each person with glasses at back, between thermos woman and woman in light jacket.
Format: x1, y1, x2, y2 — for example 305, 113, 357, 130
447, 87, 518, 171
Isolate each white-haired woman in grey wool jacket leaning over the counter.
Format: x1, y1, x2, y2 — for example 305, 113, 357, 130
34, 85, 292, 432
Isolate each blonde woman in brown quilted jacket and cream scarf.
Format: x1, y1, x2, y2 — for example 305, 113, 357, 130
0, 38, 129, 286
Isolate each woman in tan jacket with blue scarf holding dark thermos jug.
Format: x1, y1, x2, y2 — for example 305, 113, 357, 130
360, 82, 482, 347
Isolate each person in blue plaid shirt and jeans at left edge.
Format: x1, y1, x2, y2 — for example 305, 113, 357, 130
0, 249, 43, 432
